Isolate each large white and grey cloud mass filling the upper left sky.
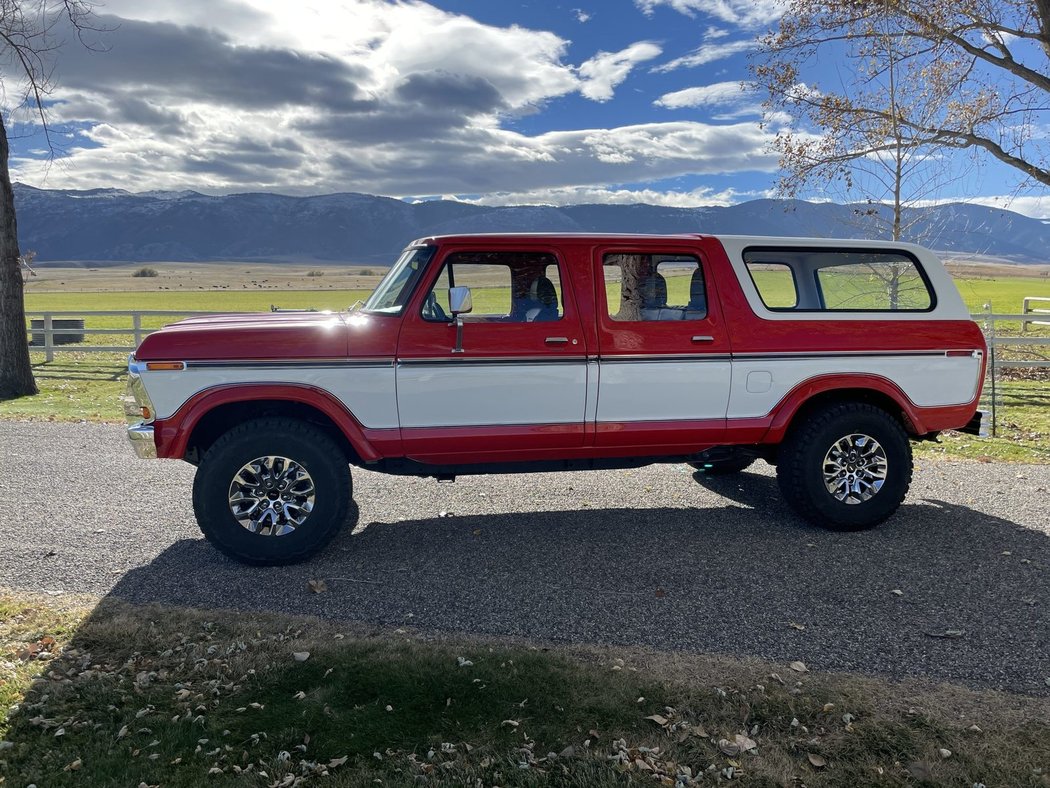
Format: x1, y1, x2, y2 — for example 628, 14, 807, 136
12, 0, 776, 196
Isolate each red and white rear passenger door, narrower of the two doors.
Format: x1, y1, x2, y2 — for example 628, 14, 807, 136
593, 242, 731, 454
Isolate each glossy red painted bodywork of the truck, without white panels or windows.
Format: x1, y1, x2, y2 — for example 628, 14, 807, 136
135, 234, 985, 464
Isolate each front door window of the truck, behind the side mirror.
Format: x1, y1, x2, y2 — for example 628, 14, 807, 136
422, 252, 564, 323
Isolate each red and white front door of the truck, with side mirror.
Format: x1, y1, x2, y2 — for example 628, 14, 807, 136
396, 245, 588, 464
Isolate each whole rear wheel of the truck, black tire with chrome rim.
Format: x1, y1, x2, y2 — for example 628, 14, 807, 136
777, 402, 911, 531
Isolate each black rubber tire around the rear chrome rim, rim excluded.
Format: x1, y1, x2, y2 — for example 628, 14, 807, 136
777, 402, 911, 531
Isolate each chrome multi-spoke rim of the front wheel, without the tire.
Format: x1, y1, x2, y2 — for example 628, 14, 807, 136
229, 456, 314, 536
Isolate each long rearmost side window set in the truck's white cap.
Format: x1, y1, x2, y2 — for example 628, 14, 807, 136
743, 248, 933, 312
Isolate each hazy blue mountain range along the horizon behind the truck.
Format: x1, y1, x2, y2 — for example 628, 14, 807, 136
15, 184, 1050, 265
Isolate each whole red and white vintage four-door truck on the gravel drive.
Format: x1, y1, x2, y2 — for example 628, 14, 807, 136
125, 234, 986, 564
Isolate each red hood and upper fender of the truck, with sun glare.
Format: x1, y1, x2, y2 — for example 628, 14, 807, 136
134, 312, 350, 361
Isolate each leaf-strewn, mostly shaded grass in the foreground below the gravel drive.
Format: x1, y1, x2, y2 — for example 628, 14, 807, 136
6, 588, 1050, 787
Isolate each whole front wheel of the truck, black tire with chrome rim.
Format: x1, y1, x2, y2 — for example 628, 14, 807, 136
193, 418, 352, 565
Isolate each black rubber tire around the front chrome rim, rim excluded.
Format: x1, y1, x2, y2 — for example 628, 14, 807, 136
193, 417, 353, 565
